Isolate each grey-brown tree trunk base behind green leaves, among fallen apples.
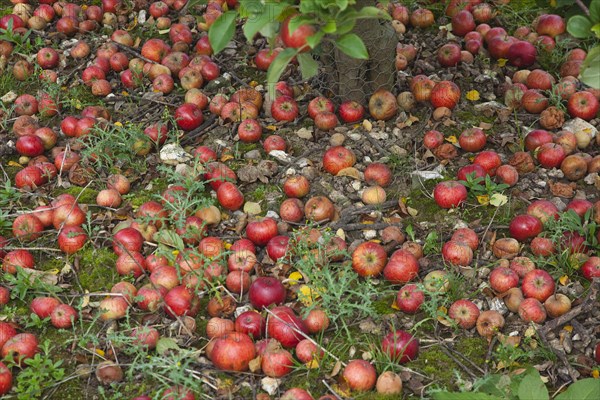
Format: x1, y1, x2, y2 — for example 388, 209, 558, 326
321, 0, 398, 104
